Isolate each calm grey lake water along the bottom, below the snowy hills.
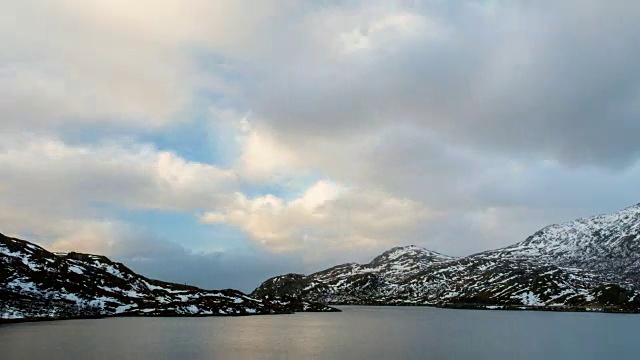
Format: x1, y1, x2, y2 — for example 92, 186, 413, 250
0, 307, 640, 360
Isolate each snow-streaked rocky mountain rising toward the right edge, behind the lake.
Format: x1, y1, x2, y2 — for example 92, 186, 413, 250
252, 205, 640, 312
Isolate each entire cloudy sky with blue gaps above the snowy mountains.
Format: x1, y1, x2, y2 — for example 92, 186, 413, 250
0, 0, 640, 291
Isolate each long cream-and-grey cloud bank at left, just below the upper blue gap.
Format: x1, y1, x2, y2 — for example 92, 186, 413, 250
0, 136, 236, 212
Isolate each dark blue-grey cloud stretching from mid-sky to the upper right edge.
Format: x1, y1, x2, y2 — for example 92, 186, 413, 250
249, 1, 640, 167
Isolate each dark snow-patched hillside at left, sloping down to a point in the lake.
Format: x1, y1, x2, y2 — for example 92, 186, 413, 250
0, 234, 337, 319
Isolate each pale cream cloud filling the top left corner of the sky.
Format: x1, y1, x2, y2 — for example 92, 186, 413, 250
0, 1, 190, 131
